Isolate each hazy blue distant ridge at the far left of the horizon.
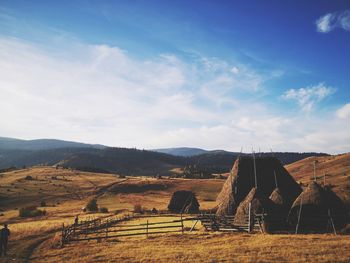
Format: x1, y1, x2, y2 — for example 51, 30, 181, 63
0, 137, 106, 151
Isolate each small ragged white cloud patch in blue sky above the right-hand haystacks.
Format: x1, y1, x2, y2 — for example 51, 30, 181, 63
282, 83, 335, 112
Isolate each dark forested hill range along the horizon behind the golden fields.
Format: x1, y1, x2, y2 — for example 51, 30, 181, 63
0, 138, 327, 175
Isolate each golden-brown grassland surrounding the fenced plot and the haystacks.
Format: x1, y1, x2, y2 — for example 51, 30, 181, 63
0, 161, 350, 262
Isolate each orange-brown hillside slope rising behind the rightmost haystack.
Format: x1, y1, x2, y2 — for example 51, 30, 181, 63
285, 153, 350, 203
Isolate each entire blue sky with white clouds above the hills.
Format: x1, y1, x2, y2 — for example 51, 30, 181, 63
0, 0, 350, 153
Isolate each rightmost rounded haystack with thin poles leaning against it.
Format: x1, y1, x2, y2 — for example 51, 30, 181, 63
288, 182, 347, 232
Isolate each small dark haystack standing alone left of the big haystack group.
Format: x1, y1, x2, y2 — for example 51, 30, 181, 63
168, 191, 199, 214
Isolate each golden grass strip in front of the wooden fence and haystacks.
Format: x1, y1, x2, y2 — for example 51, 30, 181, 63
31, 232, 350, 262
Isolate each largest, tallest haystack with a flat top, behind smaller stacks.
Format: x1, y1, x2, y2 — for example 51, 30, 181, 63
216, 156, 301, 216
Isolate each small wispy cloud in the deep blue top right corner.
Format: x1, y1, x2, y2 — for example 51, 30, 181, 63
315, 10, 350, 33
